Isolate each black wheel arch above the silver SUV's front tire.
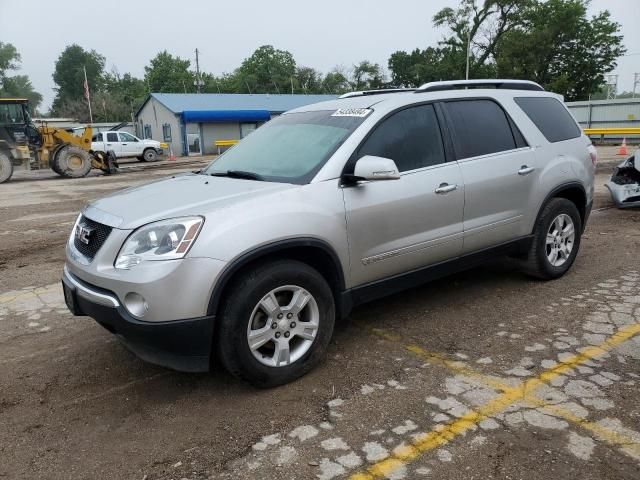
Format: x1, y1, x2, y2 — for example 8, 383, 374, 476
207, 237, 350, 316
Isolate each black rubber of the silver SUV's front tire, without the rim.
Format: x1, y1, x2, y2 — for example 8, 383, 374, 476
214, 260, 335, 388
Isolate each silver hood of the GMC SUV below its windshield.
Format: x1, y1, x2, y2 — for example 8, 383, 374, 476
83, 174, 296, 230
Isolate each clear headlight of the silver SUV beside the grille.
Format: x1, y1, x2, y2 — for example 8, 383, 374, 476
115, 217, 204, 270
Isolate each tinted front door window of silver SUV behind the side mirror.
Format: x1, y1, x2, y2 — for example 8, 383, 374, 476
358, 105, 445, 172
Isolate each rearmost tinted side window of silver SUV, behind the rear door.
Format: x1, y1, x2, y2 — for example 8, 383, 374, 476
514, 97, 580, 143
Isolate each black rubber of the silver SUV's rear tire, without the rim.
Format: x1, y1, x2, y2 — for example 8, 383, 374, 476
523, 198, 582, 280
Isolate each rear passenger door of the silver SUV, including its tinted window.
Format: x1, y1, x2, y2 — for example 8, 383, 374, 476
442, 98, 539, 253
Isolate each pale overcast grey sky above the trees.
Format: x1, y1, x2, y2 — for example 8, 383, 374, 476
0, 0, 640, 110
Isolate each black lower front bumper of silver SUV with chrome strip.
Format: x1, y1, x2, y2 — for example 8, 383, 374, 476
62, 266, 215, 372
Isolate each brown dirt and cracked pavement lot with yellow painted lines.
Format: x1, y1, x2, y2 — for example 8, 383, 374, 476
0, 149, 640, 480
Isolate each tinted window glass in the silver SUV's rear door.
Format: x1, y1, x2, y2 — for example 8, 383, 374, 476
444, 100, 524, 159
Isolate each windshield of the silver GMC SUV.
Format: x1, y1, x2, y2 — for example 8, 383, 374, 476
202, 110, 364, 184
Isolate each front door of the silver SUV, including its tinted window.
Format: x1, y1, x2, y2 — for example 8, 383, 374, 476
343, 105, 464, 286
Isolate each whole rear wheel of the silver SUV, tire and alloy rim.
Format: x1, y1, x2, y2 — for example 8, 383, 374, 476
524, 198, 582, 280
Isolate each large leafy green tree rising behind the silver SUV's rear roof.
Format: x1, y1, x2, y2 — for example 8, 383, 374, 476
497, 0, 626, 101
